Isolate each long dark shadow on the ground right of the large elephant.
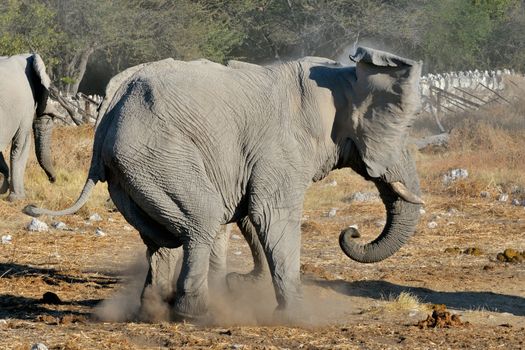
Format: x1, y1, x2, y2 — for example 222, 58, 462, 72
307, 280, 525, 316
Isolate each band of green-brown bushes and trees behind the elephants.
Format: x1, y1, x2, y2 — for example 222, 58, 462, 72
0, 0, 525, 93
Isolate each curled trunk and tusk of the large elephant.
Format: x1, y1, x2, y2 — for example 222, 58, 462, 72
339, 152, 423, 263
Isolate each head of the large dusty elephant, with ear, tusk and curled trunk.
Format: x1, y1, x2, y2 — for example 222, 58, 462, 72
339, 48, 423, 262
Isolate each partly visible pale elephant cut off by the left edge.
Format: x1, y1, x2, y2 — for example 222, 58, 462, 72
0, 54, 56, 201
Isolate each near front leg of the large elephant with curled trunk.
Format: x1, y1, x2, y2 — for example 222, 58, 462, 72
252, 204, 302, 321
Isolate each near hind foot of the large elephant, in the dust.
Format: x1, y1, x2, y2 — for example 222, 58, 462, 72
170, 294, 211, 324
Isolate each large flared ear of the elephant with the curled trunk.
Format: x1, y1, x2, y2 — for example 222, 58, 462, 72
350, 47, 422, 177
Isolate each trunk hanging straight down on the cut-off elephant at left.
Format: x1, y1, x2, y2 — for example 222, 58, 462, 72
33, 115, 56, 182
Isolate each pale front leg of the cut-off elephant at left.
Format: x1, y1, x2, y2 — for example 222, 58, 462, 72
8, 128, 31, 201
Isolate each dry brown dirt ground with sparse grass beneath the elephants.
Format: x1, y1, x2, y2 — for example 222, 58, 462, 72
0, 122, 525, 349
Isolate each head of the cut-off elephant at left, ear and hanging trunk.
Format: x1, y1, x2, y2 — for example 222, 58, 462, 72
26, 54, 56, 182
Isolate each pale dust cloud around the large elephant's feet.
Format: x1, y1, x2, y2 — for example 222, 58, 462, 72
94, 254, 356, 327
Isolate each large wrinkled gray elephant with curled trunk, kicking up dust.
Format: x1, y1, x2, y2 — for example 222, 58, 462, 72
25, 48, 422, 318
